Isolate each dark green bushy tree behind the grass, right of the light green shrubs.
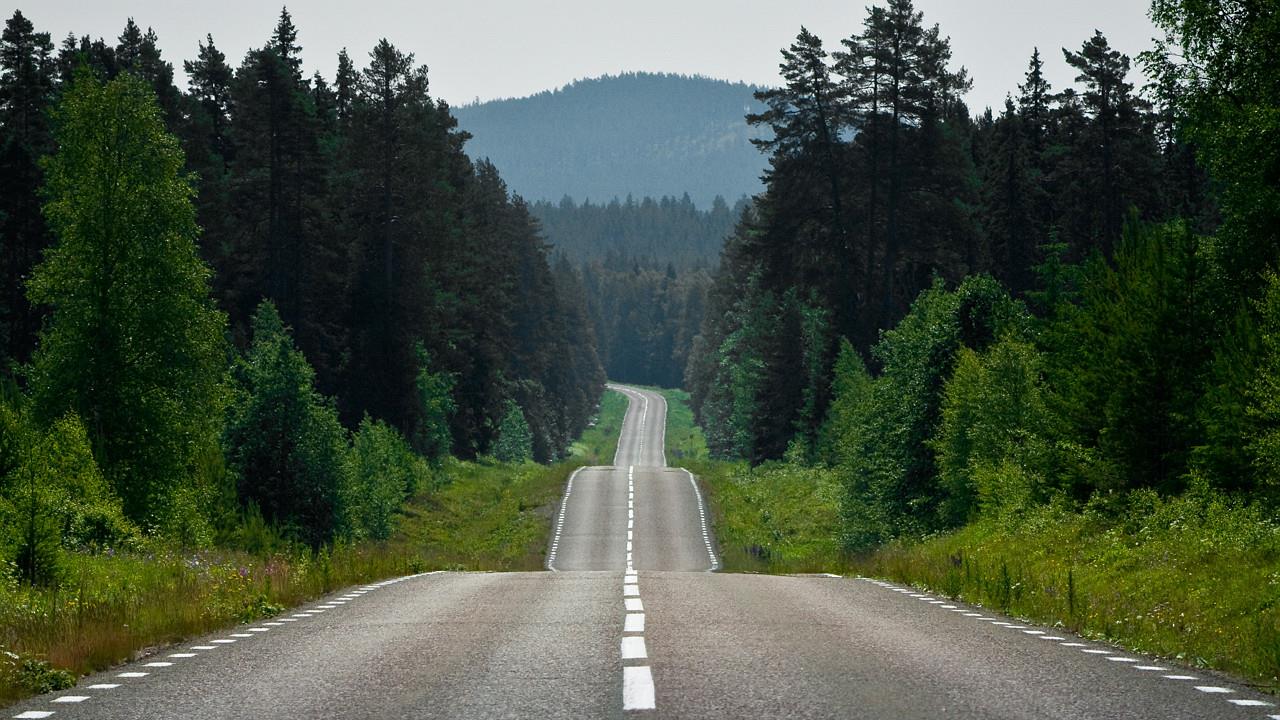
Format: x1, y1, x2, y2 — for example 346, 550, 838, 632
1047, 222, 1222, 492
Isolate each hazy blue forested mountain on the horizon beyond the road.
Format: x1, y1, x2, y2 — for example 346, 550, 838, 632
453, 73, 767, 208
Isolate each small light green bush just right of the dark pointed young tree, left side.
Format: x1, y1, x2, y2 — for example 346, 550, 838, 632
346, 418, 431, 541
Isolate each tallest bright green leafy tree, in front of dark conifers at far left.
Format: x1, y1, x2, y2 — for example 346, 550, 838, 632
28, 73, 225, 525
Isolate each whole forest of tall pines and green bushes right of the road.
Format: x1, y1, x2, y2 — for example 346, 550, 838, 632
685, 0, 1280, 552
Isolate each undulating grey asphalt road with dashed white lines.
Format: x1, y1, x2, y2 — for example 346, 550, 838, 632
12, 387, 1280, 720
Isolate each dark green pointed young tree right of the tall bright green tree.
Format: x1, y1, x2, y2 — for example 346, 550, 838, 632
224, 302, 352, 546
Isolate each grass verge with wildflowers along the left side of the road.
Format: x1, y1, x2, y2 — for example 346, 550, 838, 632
0, 384, 626, 706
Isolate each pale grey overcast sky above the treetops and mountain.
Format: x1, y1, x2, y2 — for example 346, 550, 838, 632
15, 0, 1155, 113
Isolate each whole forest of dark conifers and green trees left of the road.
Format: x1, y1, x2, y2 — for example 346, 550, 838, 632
0, 5, 604, 568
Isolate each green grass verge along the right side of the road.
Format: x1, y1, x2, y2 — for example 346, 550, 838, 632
668, 384, 1280, 692
